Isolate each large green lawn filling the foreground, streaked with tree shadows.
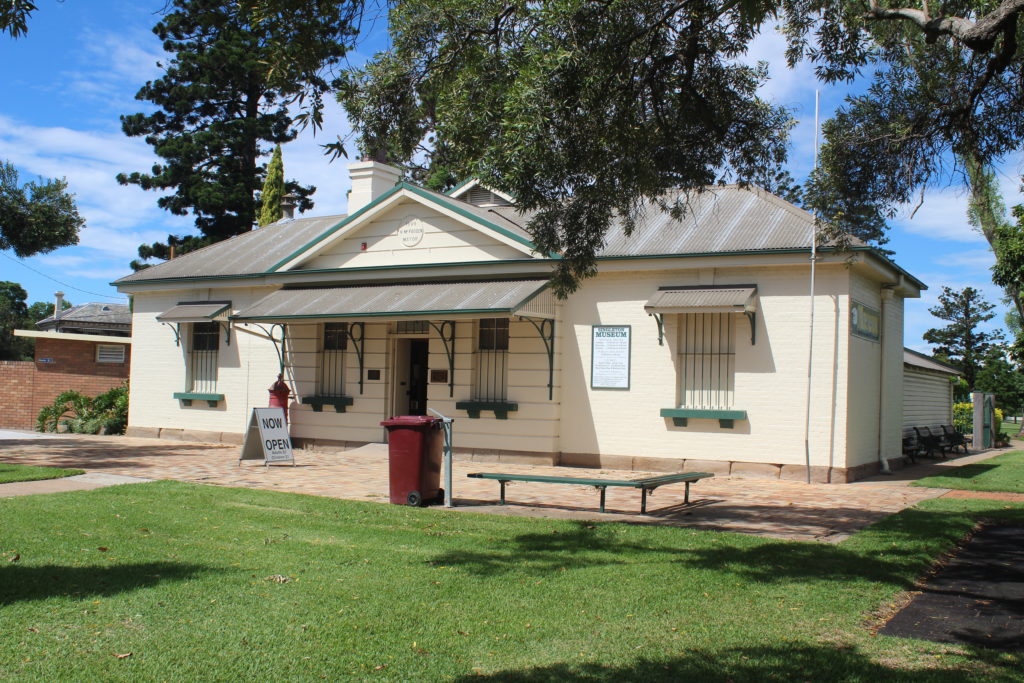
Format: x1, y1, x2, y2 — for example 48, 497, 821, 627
0, 481, 1024, 683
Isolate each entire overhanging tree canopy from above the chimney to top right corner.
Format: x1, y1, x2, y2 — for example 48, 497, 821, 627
244, 0, 1024, 293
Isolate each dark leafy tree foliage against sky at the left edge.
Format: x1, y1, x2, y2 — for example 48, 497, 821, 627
0, 161, 85, 257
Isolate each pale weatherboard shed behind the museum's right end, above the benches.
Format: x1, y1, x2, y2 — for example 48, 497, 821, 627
903, 348, 961, 427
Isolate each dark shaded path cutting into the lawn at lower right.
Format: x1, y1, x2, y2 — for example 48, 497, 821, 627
879, 525, 1024, 652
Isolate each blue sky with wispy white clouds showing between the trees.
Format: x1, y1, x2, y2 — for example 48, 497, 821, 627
0, 0, 1024, 350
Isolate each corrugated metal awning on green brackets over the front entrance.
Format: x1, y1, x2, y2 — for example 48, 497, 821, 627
231, 280, 550, 321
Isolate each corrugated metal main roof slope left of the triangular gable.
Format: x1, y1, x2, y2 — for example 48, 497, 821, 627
115, 215, 345, 284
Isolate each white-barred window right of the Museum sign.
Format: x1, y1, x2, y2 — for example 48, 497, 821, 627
679, 313, 736, 409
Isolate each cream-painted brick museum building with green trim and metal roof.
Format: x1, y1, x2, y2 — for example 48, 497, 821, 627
116, 162, 924, 481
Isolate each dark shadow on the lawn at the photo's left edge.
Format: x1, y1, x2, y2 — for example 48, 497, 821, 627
0, 562, 214, 605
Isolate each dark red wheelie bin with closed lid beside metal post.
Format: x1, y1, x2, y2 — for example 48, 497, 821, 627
381, 415, 444, 507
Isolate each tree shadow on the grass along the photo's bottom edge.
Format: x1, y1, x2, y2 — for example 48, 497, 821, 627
455, 644, 1020, 683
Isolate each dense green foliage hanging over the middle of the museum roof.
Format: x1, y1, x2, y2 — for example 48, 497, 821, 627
335, 0, 792, 294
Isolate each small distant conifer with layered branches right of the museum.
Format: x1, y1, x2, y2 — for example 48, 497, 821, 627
924, 287, 1002, 391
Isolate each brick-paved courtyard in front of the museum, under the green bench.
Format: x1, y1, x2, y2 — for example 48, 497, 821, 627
0, 433, 958, 542
